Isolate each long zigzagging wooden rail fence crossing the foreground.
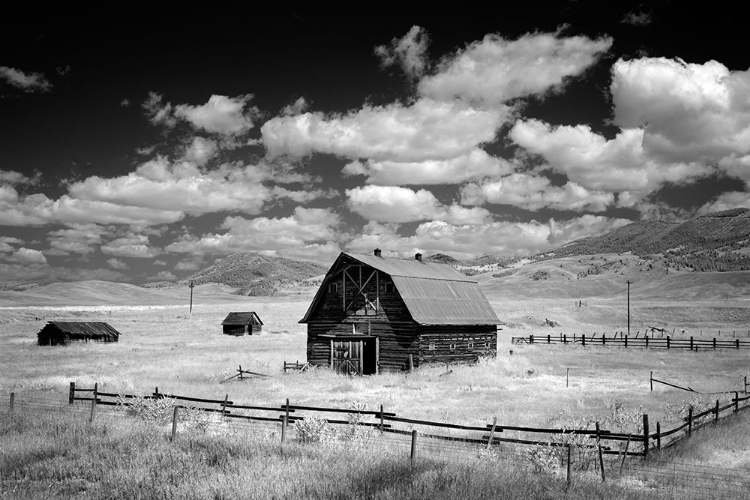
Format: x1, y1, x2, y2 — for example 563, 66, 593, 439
63, 377, 750, 460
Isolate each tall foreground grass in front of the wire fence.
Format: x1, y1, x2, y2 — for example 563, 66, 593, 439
0, 408, 666, 500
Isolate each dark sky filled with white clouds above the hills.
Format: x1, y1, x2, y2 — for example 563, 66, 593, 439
0, 0, 750, 283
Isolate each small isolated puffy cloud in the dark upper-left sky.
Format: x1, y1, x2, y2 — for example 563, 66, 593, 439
142, 92, 260, 136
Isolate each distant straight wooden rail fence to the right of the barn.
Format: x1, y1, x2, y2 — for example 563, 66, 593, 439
511, 333, 750, 351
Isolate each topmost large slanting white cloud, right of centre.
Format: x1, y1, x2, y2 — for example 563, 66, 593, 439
419, 33, 612, 107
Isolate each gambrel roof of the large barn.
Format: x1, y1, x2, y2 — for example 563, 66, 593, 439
300, 252, 503, 325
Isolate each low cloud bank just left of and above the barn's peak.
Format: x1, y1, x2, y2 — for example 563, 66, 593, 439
165, 207, 341, 262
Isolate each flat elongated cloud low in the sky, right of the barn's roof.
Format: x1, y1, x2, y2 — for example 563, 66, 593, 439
461, 173, 614, 212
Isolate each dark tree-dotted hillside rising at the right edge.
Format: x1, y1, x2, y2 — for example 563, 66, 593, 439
547, 208, 750, 271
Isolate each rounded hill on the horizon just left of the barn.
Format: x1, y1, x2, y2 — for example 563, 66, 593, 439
184, 252, 327, 296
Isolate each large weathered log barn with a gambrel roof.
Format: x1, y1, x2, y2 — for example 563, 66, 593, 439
300, 249, 502, 375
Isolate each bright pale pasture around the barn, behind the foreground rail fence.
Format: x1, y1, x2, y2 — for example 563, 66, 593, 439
0, 287, 750, 464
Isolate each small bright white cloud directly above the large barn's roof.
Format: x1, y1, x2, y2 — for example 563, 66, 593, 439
346, 185, 491, 224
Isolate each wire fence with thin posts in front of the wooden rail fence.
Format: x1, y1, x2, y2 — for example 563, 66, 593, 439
5, 394, 750, 499
